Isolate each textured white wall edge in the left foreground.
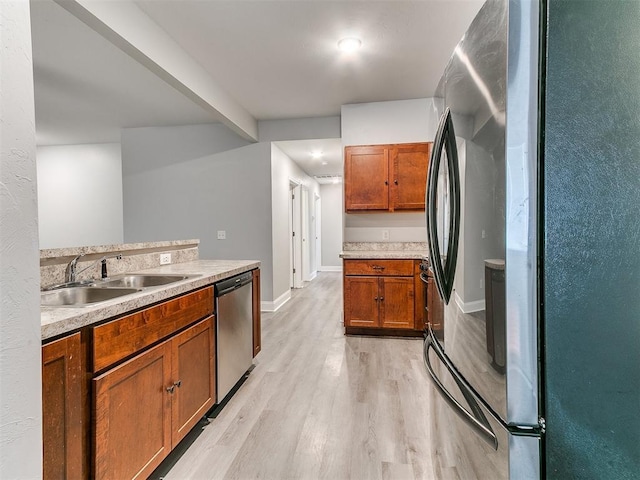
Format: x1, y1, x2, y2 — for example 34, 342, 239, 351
0, 1, 42, 479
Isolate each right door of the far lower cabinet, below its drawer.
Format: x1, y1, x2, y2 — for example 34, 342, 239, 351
380, 277, 415, 329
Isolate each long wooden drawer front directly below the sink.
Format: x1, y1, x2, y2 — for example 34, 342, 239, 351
91, 287, 213, 373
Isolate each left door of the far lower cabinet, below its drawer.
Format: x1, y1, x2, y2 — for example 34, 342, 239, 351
344, 277, 380, 327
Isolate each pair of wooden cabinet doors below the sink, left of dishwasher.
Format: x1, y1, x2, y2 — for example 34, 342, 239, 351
93, 317, 215, 479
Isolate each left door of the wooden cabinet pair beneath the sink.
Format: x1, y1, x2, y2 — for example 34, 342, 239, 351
93, 341, 173, 479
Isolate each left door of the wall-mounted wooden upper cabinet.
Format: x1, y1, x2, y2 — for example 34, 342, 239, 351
344, 145, 389, 211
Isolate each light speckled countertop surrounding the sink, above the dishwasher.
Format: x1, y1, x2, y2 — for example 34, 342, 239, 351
40, 260, 260, 340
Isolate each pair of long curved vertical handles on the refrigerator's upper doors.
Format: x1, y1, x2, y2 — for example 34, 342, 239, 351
425, 108, 460, 304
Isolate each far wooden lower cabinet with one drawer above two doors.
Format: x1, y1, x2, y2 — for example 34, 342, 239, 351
343, 259, 416, 331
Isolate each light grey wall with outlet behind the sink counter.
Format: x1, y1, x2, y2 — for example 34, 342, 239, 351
122, 125, 273, 301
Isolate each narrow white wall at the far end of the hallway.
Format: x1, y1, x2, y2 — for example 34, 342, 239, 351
320, 183, 343, 271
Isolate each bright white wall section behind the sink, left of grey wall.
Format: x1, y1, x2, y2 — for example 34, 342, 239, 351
37, 143, 124, 248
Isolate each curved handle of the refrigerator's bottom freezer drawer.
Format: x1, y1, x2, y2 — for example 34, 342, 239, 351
423, 330, 498, 450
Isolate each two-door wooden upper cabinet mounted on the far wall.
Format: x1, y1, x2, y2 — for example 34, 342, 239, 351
344, 143, 432, 212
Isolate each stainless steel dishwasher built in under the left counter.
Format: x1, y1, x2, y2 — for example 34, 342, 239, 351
215, 272, 253, 404
